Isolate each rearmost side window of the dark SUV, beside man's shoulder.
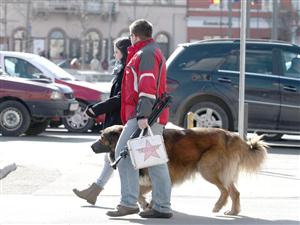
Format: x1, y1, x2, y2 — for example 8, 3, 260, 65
169, 46, 228, 71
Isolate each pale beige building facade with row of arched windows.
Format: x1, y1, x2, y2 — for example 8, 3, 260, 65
0, 0, 187, 67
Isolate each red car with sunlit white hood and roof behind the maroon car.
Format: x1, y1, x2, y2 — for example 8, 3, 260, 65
0, 51, 111, 132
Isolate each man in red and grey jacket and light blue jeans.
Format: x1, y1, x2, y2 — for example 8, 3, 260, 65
106, 19, 172, 218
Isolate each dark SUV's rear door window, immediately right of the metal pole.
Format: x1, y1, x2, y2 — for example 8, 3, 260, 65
246, 51, 273, 74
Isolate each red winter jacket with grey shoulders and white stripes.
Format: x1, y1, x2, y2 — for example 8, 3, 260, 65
121, 38, 169, 125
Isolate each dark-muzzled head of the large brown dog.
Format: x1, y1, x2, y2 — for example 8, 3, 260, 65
91, 125, 123, 153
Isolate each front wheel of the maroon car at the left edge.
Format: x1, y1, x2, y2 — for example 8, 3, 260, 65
0, 100, 31, 136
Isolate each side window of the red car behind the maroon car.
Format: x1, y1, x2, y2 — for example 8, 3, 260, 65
4, 57, 42, 78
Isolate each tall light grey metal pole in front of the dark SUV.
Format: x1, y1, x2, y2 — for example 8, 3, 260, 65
238, 1, 247, 139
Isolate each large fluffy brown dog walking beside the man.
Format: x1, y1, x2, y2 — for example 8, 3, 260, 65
99, 125, 267, 215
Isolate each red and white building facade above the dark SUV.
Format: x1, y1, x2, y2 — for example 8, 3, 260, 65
187, 0, 300, 44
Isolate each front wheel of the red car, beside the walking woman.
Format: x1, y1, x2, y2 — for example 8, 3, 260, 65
62, 102, 95, 133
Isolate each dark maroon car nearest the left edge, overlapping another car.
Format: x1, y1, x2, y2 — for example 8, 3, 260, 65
0, 73, 79, 136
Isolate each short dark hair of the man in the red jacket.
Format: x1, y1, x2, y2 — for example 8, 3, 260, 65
129, 19, 152, 40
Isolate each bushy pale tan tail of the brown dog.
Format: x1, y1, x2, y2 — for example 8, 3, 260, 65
240, 134, 269, 172
